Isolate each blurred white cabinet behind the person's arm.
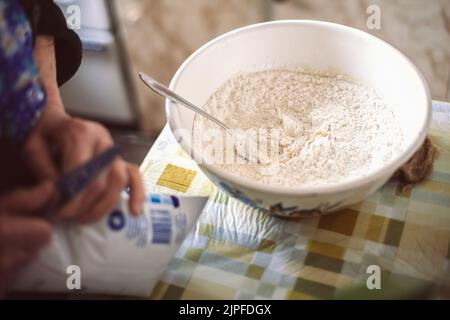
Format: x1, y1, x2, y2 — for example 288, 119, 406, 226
56, 0, 137, 126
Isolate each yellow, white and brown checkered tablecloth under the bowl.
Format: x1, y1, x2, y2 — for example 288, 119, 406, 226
141, 102, 450, 299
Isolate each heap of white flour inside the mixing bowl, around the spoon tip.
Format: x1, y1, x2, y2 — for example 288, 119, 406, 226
195, 70, 403, 187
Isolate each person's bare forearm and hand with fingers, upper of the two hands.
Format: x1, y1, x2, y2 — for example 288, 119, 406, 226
24, 36, 144, 223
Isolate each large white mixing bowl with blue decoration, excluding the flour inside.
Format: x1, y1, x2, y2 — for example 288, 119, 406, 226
166, 20, 431, 217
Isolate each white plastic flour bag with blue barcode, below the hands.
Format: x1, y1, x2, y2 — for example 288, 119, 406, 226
14, 193, 207, 297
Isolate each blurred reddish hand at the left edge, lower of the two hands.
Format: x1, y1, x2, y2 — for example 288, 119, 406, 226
0, 182, 54, 298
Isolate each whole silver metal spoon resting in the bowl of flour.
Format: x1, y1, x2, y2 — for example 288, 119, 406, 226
139, 72, 271, 165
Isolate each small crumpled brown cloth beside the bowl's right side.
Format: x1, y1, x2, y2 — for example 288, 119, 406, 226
392, 137, 439, 187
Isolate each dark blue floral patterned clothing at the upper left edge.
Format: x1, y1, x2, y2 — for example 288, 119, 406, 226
0, 0, 46, 141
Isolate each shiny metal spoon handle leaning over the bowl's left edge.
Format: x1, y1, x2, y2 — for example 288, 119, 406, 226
139, 72, 231, 134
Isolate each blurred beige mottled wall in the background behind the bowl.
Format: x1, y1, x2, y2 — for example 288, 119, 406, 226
116, 0, 450, 132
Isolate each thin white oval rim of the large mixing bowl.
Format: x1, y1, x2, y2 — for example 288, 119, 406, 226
165, 19, 432, 196
